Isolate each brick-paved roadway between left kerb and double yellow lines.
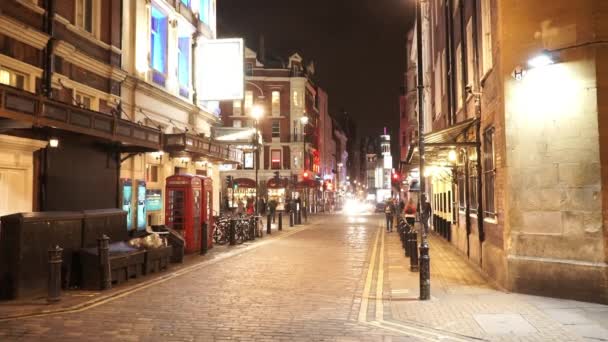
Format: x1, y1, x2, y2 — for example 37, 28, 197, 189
0, 215, 418, 341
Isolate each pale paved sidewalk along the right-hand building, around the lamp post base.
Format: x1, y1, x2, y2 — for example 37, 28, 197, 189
383, 227, 608, 341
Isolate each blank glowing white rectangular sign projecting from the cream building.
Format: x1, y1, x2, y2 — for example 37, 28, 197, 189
197, 38, 245, 101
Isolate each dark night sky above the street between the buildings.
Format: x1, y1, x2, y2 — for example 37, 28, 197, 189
218, 0, 415, 150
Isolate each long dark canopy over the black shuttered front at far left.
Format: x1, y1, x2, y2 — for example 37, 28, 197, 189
0, 84, 162, 152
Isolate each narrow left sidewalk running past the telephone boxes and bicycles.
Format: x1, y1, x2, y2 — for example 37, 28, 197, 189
0, 214, 323, 321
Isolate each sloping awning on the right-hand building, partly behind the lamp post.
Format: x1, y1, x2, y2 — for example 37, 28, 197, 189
401, 119, 479, 172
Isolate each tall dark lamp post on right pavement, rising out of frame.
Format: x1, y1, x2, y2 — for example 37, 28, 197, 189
416, 0, 431, 300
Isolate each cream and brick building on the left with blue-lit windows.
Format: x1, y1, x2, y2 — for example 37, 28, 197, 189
0, 0, 242, 229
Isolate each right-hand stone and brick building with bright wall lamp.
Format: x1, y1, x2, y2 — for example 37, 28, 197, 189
404, 0, 608, 303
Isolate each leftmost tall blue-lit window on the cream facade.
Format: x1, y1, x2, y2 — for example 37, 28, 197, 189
150, 6, 168, 86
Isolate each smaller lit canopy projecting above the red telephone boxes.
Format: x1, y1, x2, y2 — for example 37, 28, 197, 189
163, 133, 243, 164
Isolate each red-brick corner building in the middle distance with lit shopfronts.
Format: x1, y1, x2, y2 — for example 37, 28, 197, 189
221, 49, 345, 211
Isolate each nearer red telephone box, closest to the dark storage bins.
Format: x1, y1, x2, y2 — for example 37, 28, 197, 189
165, 175, 205, 253
